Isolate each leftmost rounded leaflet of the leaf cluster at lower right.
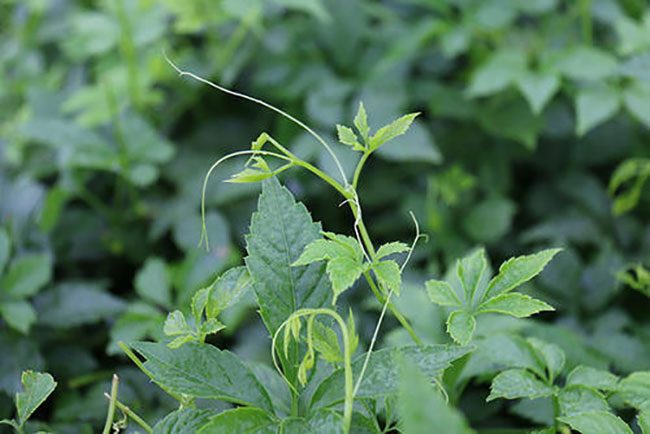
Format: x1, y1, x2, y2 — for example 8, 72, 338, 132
487, 369, 555, 402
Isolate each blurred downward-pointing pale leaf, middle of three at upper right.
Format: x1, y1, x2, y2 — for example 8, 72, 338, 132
576, 85, 621, 136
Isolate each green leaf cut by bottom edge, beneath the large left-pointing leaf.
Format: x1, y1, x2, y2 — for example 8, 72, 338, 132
197, 407, 279, 434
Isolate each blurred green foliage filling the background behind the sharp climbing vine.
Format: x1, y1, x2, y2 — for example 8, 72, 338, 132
0, 0, 650, 433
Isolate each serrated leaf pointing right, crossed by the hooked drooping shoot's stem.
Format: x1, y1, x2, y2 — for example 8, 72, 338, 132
310, 345, 472, 409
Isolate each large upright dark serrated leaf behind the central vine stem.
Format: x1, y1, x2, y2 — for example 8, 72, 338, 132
246, 179, 331, 335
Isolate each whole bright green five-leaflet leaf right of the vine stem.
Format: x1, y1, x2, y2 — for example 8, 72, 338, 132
425, 249, 560, 345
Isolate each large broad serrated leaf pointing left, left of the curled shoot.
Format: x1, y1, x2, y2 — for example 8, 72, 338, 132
132, 342, 273, 413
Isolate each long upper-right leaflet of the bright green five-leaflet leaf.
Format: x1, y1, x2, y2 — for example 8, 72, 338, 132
484, 249, 562, 299
